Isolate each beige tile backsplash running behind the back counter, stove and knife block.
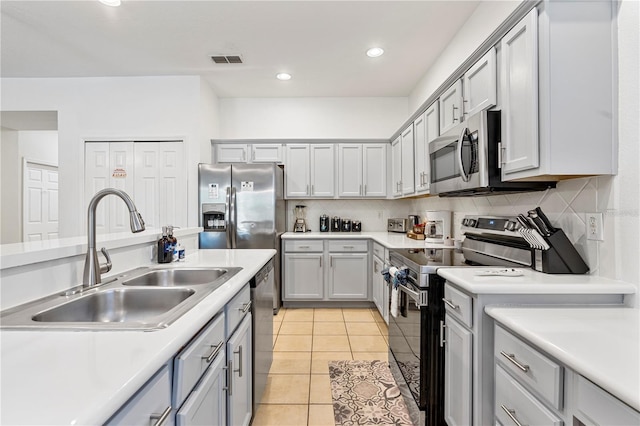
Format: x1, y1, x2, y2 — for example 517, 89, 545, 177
287, 177, 613, 275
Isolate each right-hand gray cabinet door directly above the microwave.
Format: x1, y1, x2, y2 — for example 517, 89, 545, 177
462, 48, 498, 117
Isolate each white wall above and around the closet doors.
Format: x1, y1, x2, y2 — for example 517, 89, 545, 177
1, 76, 217, 237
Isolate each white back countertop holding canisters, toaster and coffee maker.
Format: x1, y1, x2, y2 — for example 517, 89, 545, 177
282, 231, 453, 249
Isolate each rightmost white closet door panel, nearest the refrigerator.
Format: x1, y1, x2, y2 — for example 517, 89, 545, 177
158, 141, 187, 226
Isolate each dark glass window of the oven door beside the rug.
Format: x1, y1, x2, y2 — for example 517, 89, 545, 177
389, 286, 424, 408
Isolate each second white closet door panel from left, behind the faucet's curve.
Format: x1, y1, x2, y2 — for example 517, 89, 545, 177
105, 142, 135, 232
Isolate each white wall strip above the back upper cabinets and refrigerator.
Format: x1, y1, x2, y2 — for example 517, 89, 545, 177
220, 98, 409, 139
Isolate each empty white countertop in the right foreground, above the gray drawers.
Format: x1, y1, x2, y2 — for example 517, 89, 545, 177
485, 306, 640, 411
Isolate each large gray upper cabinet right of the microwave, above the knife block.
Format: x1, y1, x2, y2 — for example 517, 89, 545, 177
500, 1, 617, 180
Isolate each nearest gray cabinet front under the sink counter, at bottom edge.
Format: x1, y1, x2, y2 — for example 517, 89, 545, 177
105, 364, 173, 426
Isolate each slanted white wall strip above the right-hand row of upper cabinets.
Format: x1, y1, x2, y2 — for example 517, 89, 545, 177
410, 0, 522, 112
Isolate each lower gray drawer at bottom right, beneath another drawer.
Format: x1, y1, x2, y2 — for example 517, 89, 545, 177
495, 364, 563, 426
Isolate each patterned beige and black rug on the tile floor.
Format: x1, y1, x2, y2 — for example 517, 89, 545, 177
329, 361, 412, 426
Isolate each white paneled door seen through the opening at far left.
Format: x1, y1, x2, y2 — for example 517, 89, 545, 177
22, 159, 58, 242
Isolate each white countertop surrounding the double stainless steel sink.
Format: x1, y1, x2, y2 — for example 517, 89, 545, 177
0, 250, 275, 425
